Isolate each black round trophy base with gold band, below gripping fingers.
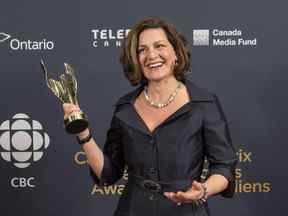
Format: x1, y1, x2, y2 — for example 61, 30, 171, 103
64, 112, 89, 134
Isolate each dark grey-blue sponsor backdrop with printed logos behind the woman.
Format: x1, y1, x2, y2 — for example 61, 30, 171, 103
0, 0, 288, 216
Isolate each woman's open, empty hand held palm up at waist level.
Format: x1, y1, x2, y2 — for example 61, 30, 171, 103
164, 181, 204, 204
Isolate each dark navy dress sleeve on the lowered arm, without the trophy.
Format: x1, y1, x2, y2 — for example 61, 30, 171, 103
204, 95, 237, 197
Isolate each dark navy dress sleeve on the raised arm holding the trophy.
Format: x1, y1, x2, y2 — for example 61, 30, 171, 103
89, 115, 125, 185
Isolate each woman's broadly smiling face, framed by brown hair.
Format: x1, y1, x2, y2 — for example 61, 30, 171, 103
138, 28, 177, 81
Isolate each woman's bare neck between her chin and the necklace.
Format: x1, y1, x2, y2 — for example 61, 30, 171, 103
147, 76, 178, 102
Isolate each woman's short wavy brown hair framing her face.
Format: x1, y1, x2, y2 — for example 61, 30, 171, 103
120, 18, 191, 86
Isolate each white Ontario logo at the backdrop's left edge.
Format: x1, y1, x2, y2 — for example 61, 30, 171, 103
0, 32, 55, 50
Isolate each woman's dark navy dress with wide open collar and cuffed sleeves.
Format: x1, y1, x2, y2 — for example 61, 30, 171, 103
90, 79, 237, 216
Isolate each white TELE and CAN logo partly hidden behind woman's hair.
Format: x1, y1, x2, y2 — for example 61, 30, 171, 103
91, 28, 130, 48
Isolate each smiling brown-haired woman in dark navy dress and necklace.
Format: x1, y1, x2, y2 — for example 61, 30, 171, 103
63, 19, 236, 216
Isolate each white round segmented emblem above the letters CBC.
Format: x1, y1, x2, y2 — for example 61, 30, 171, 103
0, 113, 50, 169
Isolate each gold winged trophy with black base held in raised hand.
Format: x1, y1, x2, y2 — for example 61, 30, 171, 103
41, 60, 89, 134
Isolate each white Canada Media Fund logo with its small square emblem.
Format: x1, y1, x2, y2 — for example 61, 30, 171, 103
193, 28, 258, 47
